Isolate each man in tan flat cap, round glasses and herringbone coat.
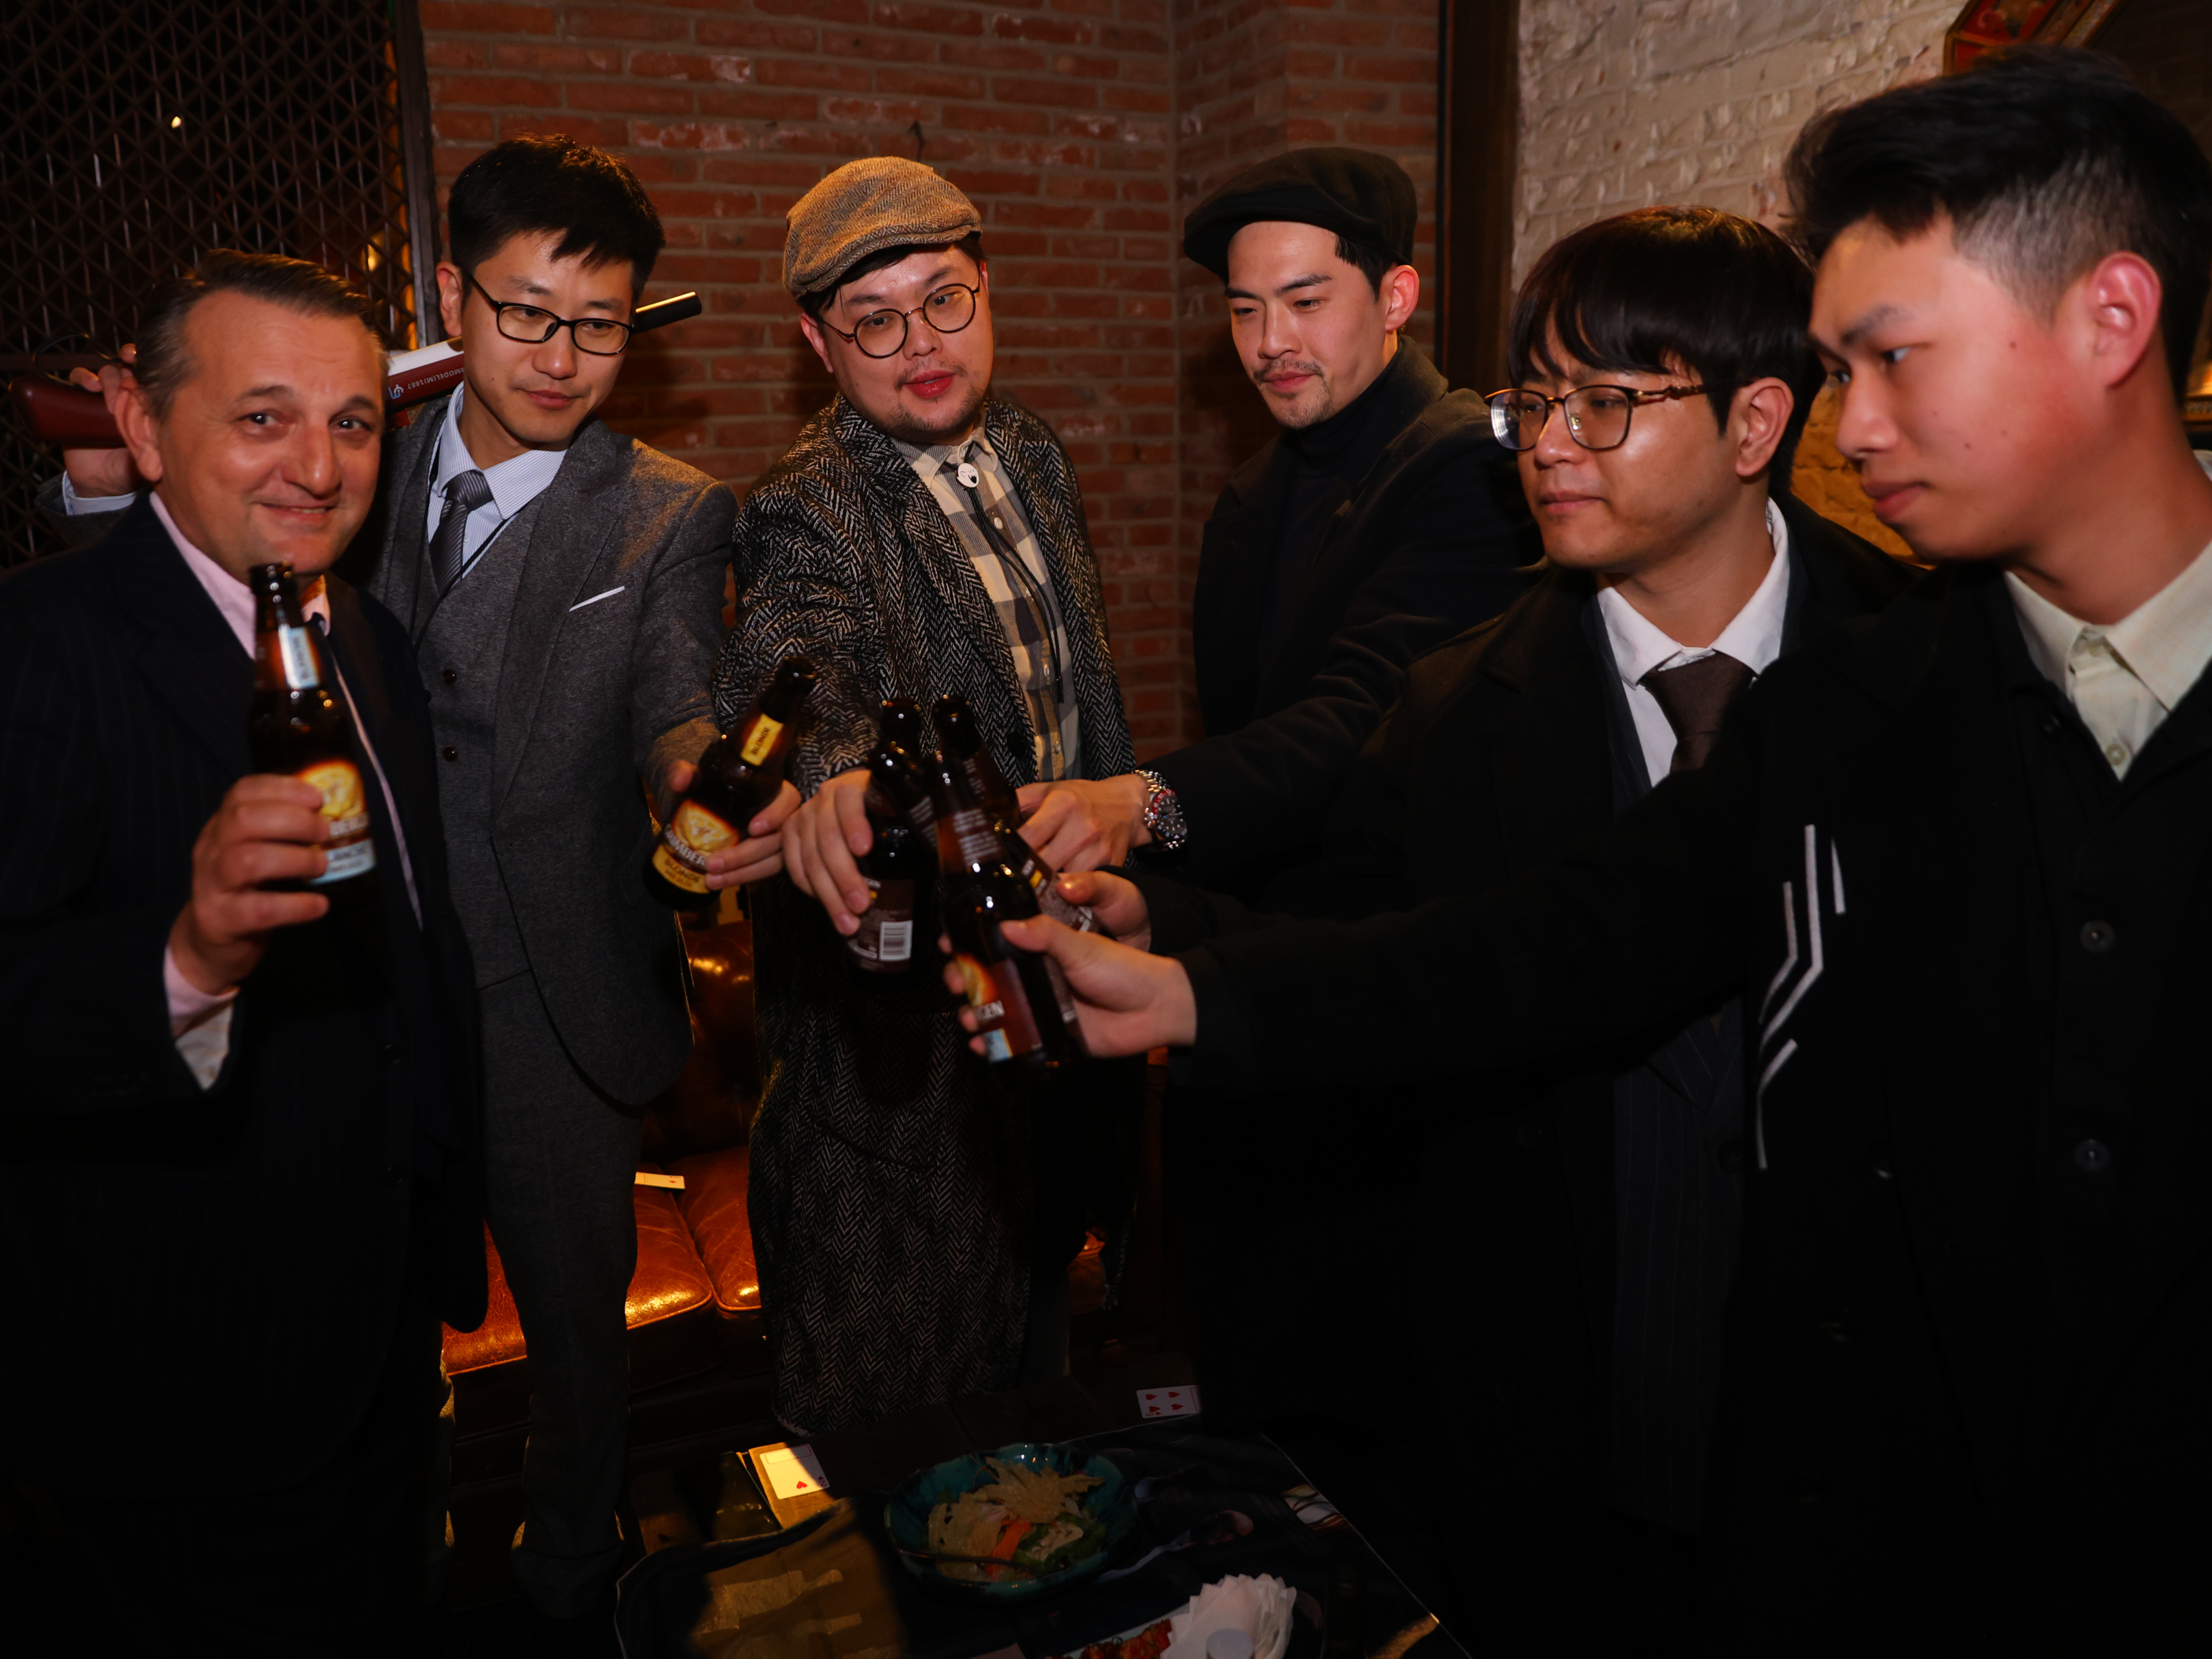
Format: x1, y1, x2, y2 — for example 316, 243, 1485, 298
712, 157, 1135, 1433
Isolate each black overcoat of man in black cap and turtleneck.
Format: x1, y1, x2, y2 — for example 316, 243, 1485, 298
1150, 345, 1542, 891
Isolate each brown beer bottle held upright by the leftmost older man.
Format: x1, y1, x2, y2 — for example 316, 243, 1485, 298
246, 564, 376, 902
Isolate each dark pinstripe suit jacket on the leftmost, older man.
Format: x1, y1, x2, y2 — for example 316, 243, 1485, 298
0, 500, 484, 1489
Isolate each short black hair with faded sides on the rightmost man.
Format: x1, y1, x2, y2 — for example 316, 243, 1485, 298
1787, 46, 2212, 396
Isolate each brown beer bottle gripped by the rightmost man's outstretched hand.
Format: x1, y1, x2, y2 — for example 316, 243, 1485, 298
929, 759, 1084, 1071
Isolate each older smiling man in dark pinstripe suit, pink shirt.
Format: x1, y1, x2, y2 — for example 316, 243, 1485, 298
0, 254, 484, 1655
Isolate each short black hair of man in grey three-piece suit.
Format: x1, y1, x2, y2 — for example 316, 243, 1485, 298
445, 133, 668, 299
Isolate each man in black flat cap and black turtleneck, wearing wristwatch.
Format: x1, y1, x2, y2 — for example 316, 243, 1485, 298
1022, 148, 1537, 894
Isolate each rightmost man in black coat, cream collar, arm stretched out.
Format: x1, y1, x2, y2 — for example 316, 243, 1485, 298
969, 51, 2212, 1655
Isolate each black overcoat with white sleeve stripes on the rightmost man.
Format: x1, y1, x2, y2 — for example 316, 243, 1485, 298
1183, 568, 2212, 1655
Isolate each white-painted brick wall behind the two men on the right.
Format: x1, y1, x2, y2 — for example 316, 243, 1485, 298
1513, 0, 1958, 553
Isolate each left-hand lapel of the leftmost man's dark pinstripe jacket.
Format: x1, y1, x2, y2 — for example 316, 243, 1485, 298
100, 495, 254, 779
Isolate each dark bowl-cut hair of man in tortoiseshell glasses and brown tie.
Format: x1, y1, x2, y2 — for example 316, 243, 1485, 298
1506, 208, 1827, 493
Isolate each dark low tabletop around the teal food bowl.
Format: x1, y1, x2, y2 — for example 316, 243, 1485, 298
619, 1363, 1464, 1659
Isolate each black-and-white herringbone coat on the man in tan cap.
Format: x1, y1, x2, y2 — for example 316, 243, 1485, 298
714, 398, 1135, 1433
